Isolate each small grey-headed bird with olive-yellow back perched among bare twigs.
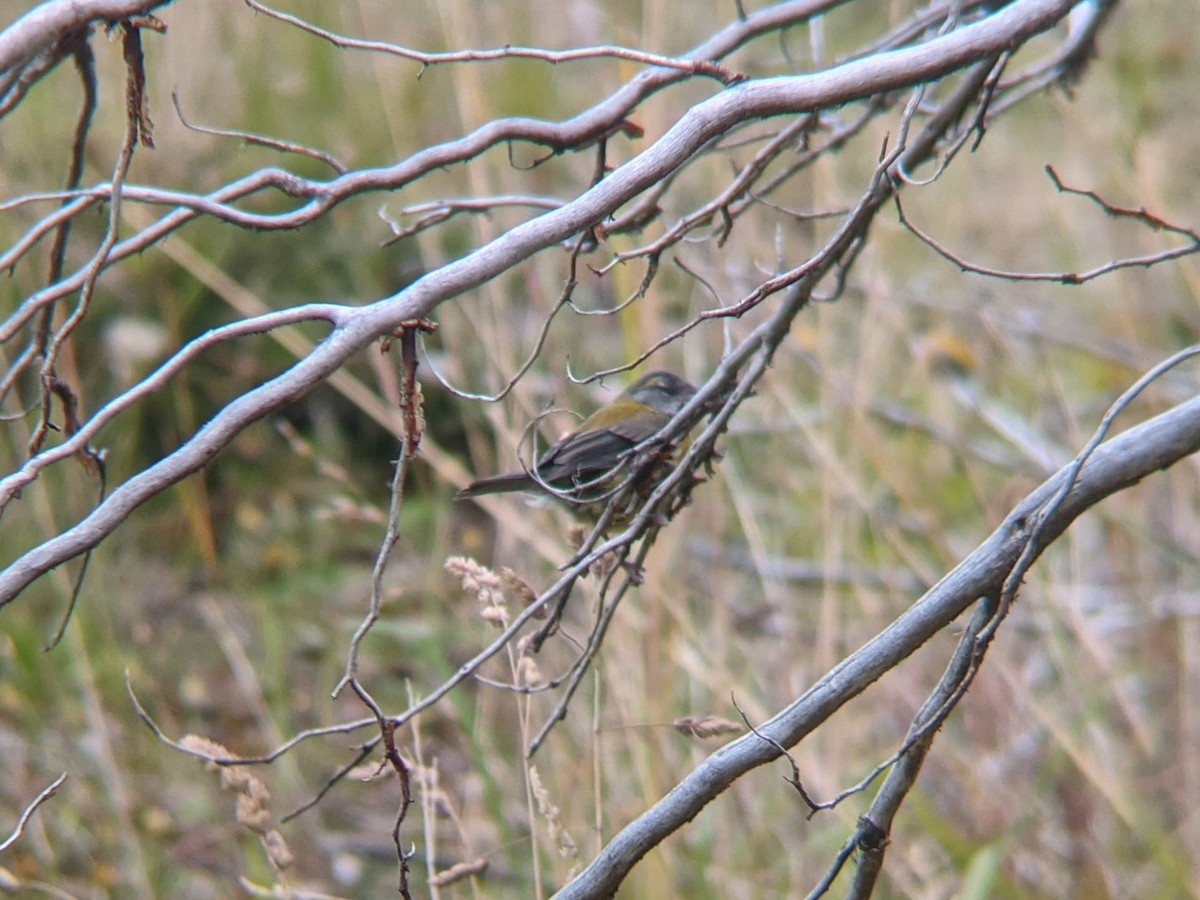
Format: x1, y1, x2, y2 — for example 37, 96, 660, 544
455, 371, 697, 506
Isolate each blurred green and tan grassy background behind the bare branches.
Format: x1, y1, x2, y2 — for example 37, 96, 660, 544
0, 0, 1200, 898
